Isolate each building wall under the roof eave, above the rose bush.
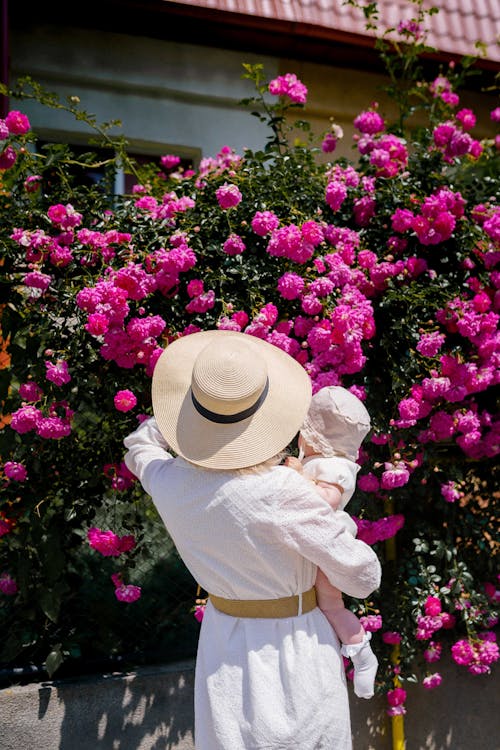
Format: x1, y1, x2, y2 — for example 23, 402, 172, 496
11, 25, 496, 167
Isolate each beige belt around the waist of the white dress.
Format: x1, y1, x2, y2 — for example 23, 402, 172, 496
209, 586, 316, 618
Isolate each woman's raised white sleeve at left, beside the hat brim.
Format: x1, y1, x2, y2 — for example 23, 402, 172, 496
123, 417, 173, 495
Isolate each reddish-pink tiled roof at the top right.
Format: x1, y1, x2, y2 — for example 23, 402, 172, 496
164, 0, 500, 62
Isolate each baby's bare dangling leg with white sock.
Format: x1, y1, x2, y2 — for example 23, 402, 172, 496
315, 569, 378, 698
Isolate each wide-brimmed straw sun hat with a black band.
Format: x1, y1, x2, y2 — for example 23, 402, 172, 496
152, 331, 311, 469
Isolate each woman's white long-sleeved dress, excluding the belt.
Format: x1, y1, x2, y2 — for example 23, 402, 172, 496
125, 419, 380, 750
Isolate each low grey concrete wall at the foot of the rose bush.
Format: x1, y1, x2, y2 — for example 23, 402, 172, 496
0, 661, 500, 750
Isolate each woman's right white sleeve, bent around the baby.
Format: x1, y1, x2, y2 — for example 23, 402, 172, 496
274, 475, 381, 599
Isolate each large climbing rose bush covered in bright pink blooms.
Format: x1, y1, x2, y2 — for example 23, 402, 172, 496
0, 2, 500, 714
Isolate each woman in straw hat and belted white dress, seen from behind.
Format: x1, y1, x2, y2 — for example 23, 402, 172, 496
125, 331, 380, 750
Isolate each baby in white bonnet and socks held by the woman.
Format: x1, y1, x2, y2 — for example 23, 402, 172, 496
286, 386, 378, 698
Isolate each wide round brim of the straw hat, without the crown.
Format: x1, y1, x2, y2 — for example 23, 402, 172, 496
152, 331, 311, 469
